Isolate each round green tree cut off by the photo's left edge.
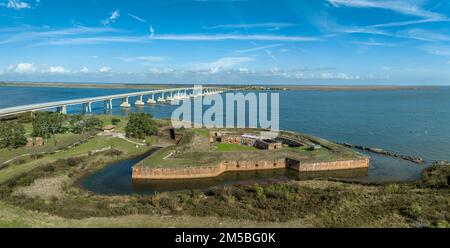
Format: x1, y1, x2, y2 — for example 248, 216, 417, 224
0, 121, 27, 149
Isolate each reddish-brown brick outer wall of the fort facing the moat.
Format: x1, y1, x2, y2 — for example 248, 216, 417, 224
132, 157, 369, 180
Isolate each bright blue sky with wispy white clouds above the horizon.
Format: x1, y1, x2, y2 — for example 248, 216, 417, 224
0, 0, 450, 85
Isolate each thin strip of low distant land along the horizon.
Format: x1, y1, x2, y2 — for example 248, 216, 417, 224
0, 82, 439, 91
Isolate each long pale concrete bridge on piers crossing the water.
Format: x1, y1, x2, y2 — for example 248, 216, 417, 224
0, 87, 227, 117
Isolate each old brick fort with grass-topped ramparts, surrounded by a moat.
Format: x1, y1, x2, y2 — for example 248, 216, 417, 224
132, 129, 369, 179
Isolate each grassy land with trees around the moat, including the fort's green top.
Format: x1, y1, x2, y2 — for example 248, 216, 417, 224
0, 113, 450, 227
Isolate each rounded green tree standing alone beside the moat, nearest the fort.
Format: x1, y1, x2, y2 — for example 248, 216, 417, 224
125, 113, 158, 139
